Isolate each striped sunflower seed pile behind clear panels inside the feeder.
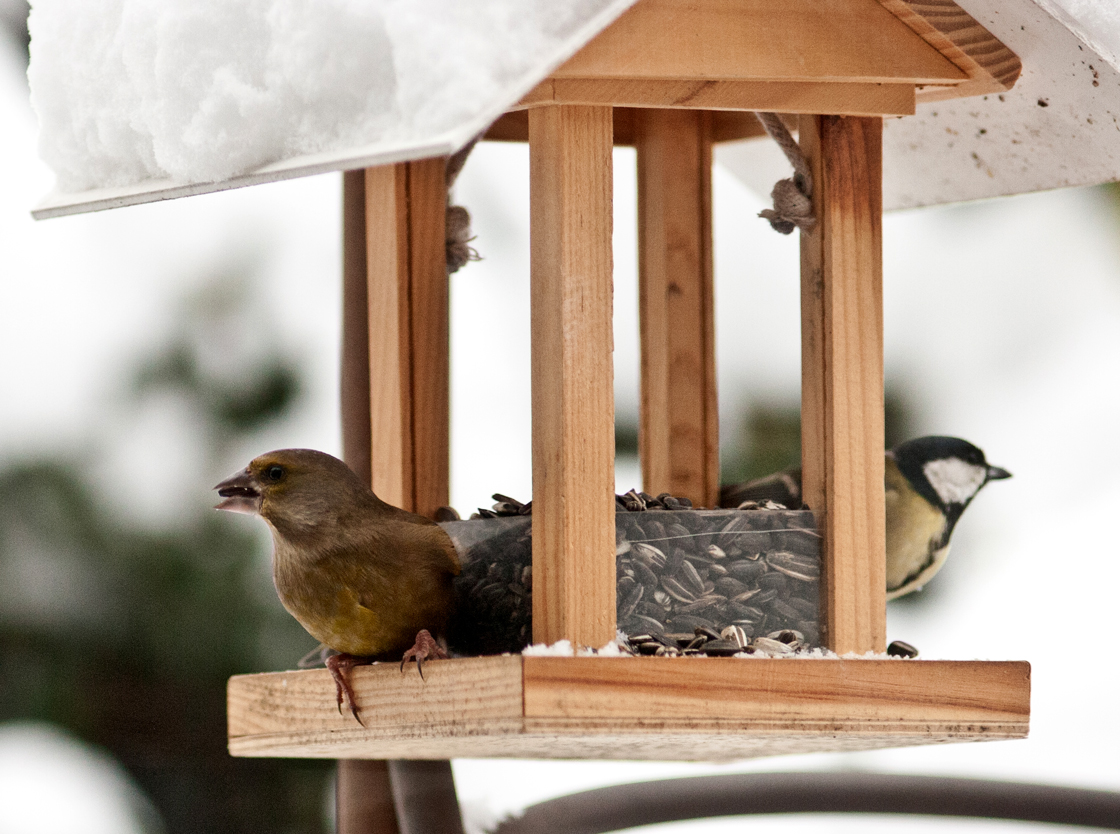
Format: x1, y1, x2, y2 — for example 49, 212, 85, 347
442, 490, 820, 656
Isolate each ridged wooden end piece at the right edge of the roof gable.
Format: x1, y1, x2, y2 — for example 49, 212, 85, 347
878, 0, 1023, 101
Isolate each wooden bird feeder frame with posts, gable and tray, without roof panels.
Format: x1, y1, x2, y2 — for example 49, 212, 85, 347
222, 0, 1029, 759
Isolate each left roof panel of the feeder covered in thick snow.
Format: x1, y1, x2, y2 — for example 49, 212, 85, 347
28, 0, 634, 217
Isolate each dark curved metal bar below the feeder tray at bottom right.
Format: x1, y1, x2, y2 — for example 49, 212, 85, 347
494, 772, 1120, 834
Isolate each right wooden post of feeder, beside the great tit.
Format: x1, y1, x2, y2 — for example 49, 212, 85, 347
800, 116, 886, 654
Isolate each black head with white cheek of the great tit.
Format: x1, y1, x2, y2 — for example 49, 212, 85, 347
889, 435, 1011, 521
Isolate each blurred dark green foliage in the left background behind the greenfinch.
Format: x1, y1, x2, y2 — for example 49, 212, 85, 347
0, 277, 330, 834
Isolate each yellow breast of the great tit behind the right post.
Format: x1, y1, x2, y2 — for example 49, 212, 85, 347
886, 457, 948, 598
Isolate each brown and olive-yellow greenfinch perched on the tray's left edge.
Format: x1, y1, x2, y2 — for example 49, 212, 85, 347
214, 449, 460, 722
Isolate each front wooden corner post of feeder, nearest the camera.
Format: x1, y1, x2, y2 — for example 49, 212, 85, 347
529, 106, 615, 647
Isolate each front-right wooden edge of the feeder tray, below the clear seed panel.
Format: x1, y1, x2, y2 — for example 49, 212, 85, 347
524, 657, 1029, 730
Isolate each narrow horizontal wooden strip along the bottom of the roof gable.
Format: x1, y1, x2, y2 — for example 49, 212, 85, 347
517, 77, 915, 115
